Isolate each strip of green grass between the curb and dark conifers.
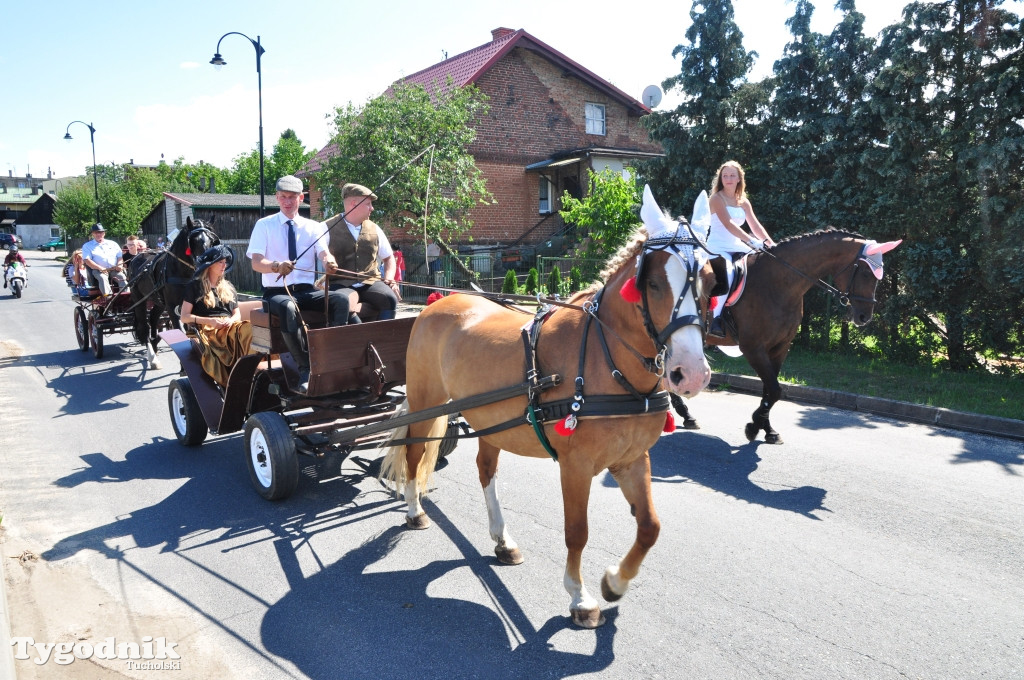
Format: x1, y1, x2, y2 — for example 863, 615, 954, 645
708, 347, 1024, 420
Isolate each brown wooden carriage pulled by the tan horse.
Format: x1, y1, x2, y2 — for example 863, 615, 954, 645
160, 300, 458, 500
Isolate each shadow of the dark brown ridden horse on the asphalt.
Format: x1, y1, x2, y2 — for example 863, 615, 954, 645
638, 431, 828, 519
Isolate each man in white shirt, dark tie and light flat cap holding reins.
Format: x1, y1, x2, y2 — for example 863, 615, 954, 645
246, 175, 348, 391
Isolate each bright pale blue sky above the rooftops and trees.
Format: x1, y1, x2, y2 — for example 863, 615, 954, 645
0, 0, 1007, 177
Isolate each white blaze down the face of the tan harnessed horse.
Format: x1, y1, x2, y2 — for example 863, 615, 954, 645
665, 255, 711, 397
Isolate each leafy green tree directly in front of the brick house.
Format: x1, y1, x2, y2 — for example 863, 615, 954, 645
316, 82, 492, 244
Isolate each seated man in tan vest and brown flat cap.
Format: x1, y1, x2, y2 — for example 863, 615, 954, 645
325, 183, 401, 321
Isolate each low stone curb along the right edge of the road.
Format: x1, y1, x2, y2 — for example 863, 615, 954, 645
711, 373, 1024, 440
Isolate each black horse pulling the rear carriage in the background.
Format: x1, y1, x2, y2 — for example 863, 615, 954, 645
128, 217, 220, 370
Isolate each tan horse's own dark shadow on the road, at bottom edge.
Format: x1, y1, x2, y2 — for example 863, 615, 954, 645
262, 503, 617, 680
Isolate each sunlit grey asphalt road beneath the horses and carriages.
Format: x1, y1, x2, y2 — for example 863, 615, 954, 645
0, 246, 1024, 680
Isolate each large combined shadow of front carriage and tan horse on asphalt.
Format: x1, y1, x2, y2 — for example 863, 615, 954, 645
42, 437, 617, 679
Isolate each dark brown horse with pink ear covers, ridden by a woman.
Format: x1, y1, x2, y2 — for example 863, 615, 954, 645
673, 227, 902, 443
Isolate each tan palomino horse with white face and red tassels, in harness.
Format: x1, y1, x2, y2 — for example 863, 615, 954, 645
381, 184, 714, 628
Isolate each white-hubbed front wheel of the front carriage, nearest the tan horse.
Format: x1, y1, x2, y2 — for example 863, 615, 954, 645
245, 411, 299, 501
